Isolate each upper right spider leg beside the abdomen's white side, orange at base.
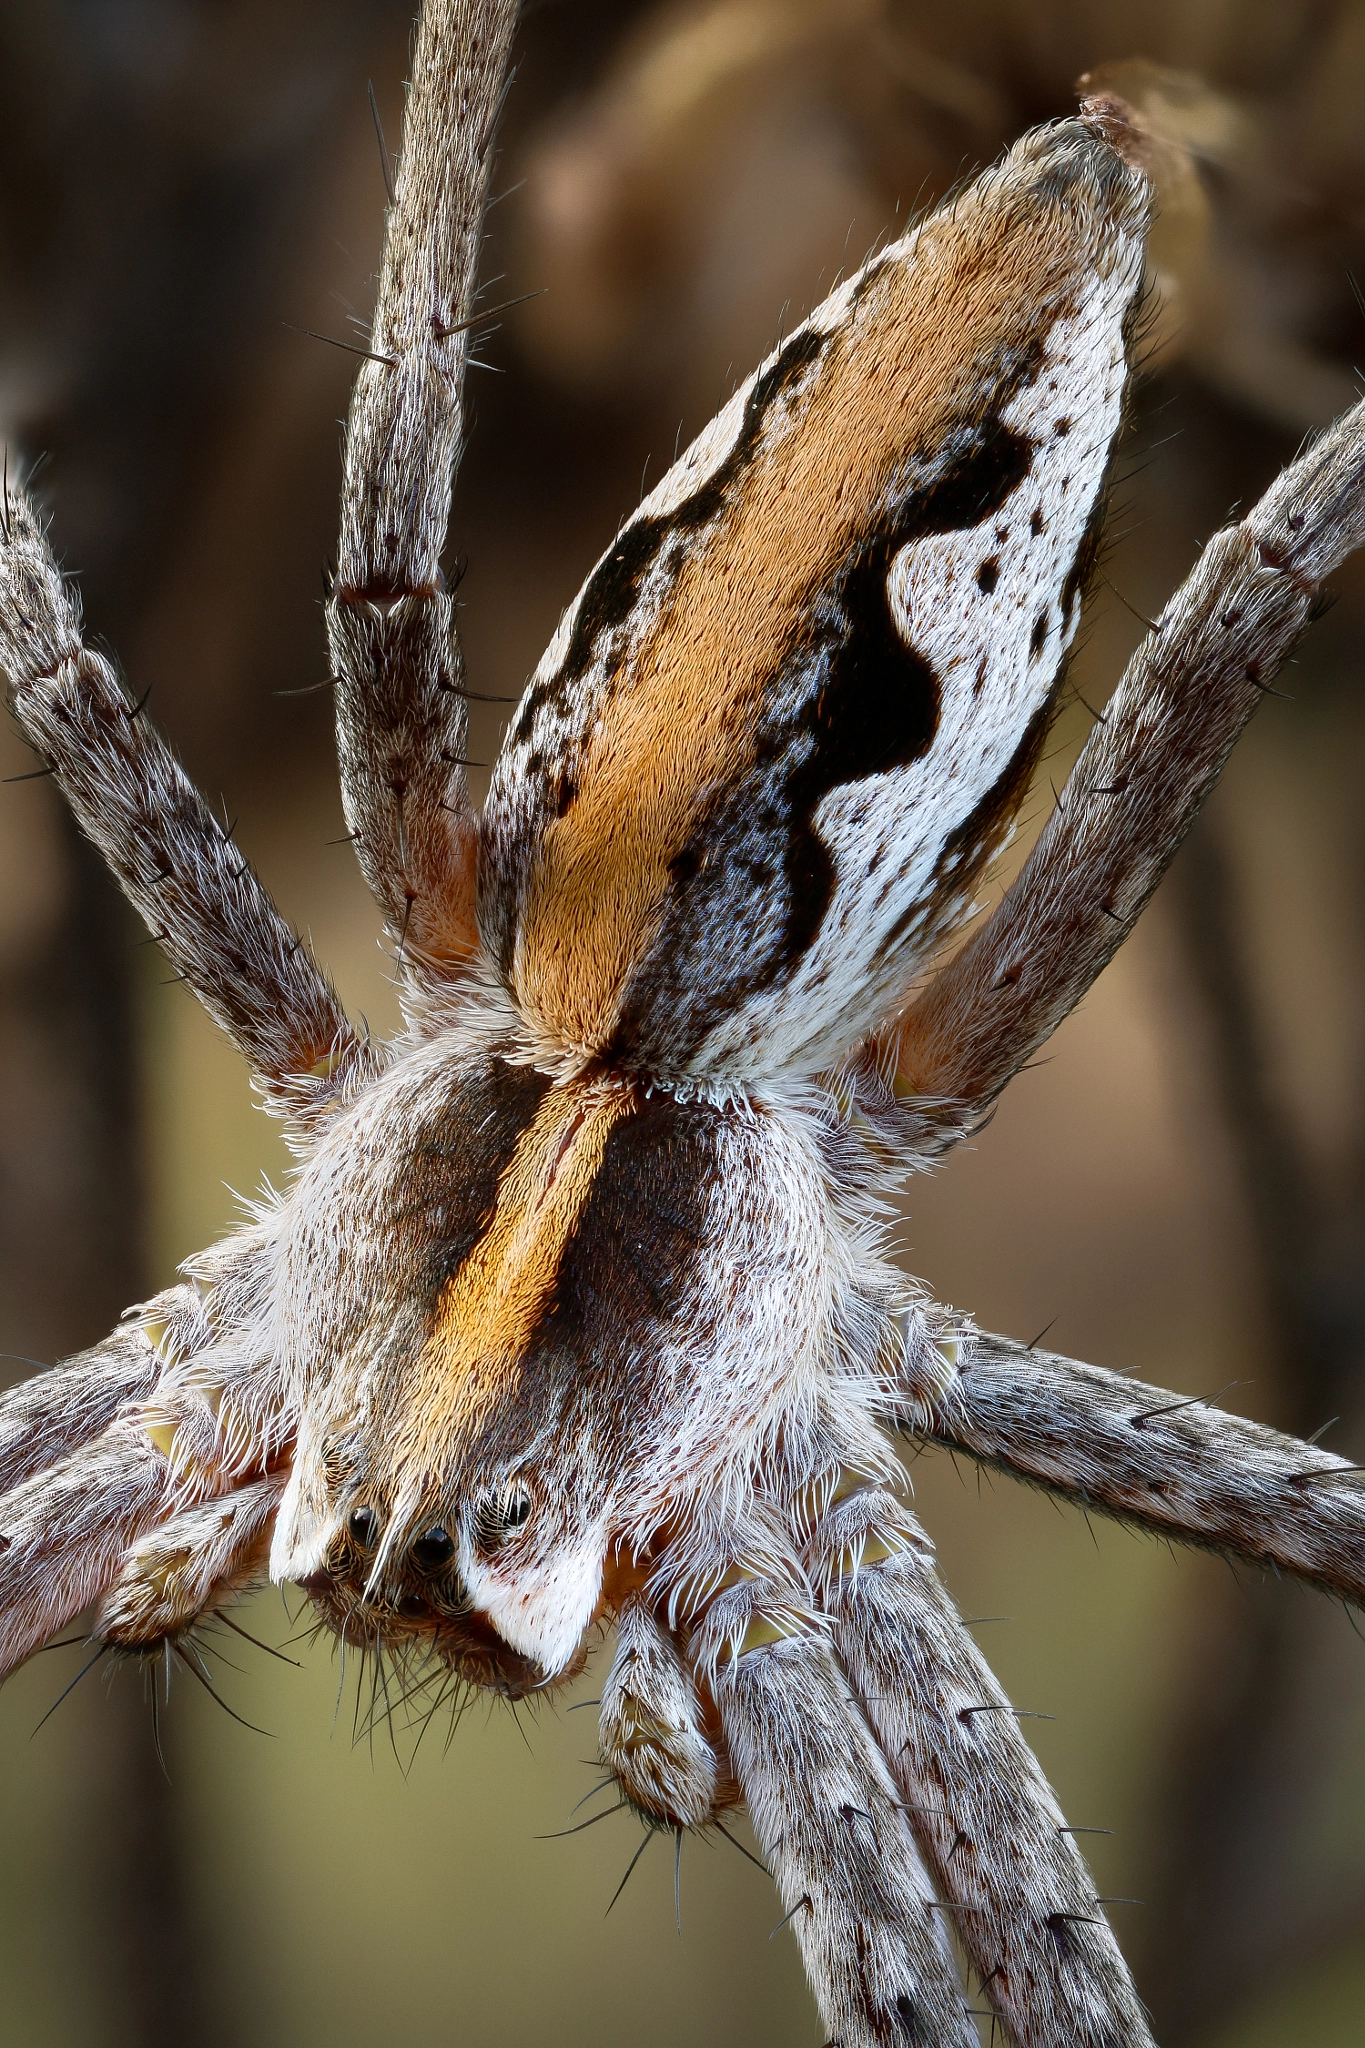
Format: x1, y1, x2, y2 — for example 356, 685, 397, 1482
864, 391, 1365, 1151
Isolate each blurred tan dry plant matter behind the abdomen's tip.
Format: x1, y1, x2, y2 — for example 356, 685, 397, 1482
509, 0, 1365, 430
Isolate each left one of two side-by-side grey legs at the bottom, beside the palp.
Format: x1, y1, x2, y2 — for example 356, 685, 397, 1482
692, 1581, 976, 2048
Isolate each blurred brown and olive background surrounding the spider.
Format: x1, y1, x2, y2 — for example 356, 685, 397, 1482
0, 0, 1365, 2048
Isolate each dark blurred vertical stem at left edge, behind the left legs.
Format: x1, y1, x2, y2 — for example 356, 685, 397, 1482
0, 825, 196, 2048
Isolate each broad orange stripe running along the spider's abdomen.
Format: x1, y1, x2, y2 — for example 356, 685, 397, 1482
514, 125, 1132, 1053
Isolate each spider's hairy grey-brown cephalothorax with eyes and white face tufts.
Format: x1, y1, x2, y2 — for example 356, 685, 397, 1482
272, 1044, 831, 1690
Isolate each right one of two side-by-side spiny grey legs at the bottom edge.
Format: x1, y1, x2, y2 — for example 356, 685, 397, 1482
810, 1487, 1150, 2048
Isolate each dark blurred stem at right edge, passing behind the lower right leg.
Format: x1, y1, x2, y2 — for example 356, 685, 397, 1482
1146, 811, 1365, 2048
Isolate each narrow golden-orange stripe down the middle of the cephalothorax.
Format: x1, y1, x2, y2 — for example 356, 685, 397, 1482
391, 1085, 634, 1473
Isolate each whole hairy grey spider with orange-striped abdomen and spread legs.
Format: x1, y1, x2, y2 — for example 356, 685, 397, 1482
0, 0, 1365, 2048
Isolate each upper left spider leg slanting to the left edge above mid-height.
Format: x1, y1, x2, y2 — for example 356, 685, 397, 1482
0, 475, 364, 1112
